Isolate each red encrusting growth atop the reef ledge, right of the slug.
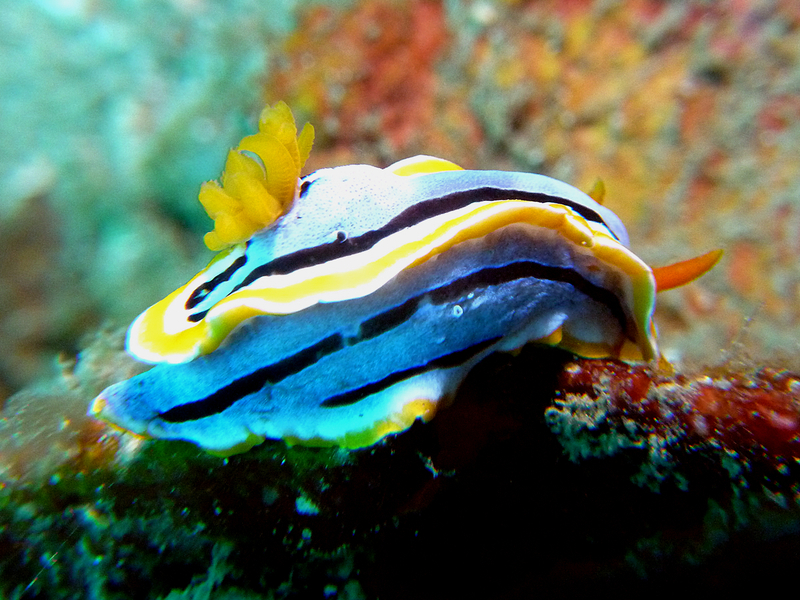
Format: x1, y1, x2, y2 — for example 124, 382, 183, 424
559, 360, 800, 464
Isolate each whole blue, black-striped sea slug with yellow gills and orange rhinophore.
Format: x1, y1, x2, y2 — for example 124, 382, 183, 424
90, 103, 719, 454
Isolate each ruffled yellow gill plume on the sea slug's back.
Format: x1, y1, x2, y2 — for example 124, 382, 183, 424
199, 101, 314, 251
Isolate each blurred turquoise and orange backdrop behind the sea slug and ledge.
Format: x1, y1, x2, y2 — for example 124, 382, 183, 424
0, 0, 800, 402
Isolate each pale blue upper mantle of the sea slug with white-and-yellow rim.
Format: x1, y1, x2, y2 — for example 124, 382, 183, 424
128, 165, 644, 363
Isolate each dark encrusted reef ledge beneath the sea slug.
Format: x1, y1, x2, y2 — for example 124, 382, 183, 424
0, 333, 800, 599
